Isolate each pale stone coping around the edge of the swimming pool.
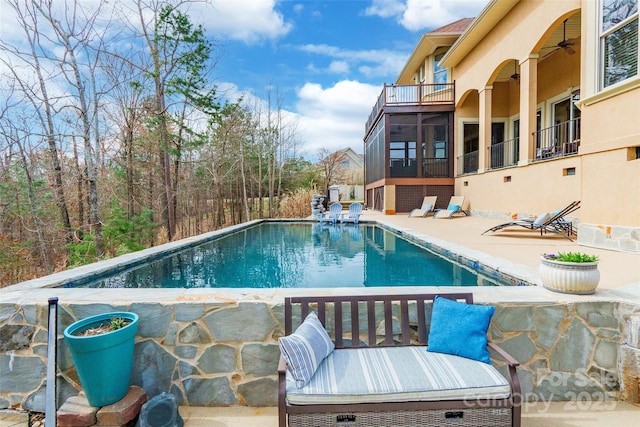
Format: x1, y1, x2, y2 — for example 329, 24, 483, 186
2, 218, 640, 304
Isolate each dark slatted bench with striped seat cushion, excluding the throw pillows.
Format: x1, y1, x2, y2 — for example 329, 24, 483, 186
278, 293, 521, 427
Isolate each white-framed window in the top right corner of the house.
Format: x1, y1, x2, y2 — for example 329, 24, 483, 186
600, 0, 640, 88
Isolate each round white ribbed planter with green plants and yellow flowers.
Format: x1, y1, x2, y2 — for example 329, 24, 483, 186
539, 252, 600, 295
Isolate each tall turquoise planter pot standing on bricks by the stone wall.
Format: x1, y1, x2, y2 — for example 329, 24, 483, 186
64, 312, 138, 407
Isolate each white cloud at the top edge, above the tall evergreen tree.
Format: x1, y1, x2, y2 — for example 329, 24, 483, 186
193, 0, 293, 43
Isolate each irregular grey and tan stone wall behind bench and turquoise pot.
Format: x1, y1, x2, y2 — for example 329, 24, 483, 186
0, 300, 640, 411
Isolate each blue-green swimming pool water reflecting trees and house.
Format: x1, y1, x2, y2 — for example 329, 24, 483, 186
66, 222, 504, 288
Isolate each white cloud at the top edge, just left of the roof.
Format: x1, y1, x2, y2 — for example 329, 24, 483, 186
365, 0, 488, 31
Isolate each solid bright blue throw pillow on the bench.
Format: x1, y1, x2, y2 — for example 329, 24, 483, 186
427, 296, 496, 364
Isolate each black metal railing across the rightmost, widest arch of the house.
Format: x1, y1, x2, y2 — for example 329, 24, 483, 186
533, 117, 580, 161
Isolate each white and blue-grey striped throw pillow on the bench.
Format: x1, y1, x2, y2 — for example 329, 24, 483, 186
278, 311, 335, 388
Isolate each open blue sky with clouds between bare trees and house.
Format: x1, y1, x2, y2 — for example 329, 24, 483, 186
191, 0, 488, 160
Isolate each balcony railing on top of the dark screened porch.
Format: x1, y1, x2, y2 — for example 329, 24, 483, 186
365, 83, 455, 132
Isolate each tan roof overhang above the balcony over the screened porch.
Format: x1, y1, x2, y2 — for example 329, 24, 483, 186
396, 18, 474, 84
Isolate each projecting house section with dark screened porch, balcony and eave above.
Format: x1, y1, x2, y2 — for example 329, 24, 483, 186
364, 19, 472, 214
